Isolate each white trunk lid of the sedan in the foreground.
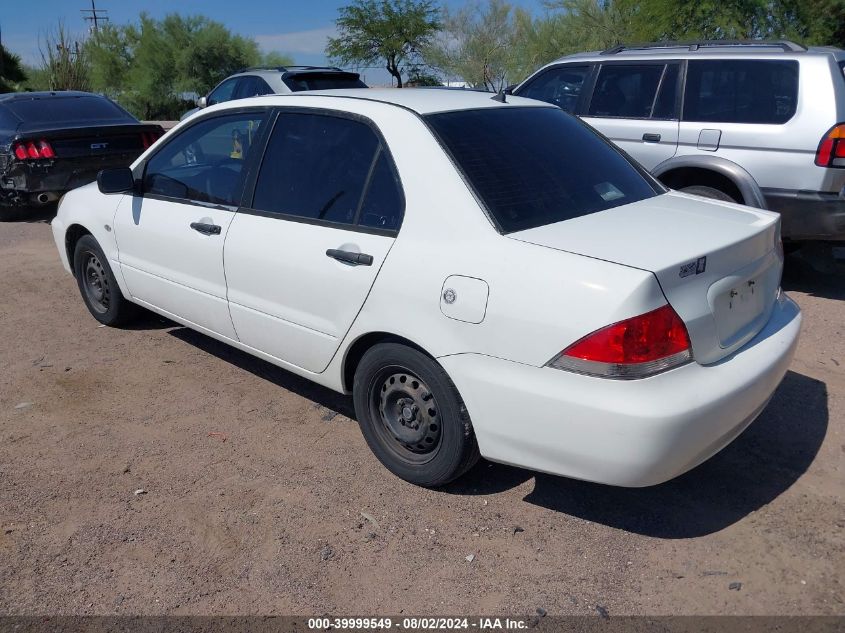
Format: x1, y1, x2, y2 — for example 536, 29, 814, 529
508, 192, 783, 364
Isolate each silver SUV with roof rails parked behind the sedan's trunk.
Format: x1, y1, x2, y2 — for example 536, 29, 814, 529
513, 41, 845, 241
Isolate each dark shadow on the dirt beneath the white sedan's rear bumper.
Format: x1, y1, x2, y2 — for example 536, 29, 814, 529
447, 372, 828, 538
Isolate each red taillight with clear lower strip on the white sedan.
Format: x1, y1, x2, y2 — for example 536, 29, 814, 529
549, 304, 692, 378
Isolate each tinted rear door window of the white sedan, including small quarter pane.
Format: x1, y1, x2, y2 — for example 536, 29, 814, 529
252, 113, 402, 230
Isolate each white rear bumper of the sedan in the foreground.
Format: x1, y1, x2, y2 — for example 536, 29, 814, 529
438, 295, 801, 487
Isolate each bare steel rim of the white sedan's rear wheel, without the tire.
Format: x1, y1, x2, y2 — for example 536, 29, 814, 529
370, 367, 442, 464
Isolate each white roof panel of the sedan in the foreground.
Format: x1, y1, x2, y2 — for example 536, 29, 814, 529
254, 88, 556, 114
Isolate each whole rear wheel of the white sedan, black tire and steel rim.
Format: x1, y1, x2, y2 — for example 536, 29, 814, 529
352, 343, 479, 487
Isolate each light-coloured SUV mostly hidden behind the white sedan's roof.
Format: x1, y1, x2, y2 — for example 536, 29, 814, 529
180, 66, 367, 120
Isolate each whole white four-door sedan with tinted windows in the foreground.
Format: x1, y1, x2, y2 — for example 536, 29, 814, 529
53, 90, 801, 486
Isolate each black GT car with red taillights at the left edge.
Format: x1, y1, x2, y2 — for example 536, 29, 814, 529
0, 91, 164, 220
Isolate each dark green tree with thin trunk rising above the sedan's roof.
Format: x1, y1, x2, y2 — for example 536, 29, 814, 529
326, 0, 441, 88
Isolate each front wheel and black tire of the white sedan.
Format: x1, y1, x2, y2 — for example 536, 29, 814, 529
73, 235, 139, 326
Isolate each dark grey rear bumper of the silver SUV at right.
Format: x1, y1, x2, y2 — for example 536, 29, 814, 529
763, 188, 845, 241
